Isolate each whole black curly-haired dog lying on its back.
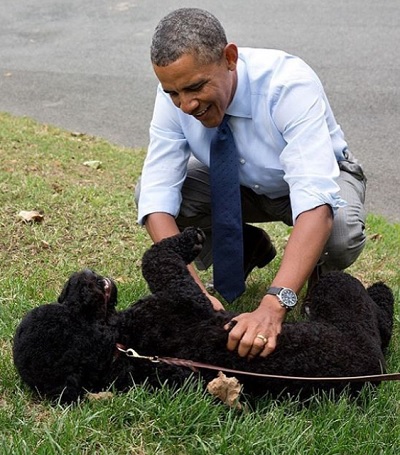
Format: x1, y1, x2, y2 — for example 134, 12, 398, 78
13, 228, 394, 402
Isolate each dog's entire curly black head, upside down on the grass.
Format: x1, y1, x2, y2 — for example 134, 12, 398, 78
13, 270, 118, 402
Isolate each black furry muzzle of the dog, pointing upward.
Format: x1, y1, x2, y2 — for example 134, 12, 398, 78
58, 269, 117, 319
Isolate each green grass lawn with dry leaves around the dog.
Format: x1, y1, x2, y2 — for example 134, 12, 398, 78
0, 114, 400, 455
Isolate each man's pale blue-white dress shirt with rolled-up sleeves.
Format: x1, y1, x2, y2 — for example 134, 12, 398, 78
138, 48, 347, 223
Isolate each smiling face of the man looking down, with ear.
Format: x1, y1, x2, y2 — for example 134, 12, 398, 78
153, 44, 237, 128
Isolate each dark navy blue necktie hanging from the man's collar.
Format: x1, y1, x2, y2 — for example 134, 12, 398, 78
210, 115, 245, 302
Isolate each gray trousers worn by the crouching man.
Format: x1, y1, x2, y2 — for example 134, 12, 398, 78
135, 158, 366, 272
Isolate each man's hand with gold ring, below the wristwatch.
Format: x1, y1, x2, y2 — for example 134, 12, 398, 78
225, 295, 286, 359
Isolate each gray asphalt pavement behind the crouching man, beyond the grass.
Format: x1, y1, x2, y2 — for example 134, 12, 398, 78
0, 0, 400, 222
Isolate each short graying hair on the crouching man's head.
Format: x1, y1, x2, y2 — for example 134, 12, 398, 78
150, 8, 228, 66
